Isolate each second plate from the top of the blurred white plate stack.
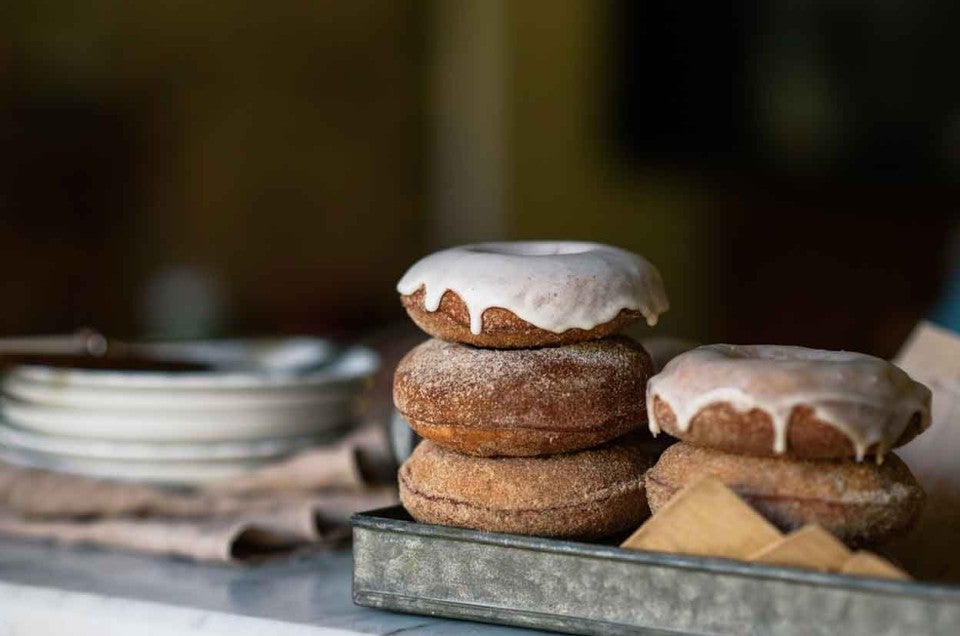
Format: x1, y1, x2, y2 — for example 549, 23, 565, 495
0, 399, 356, 442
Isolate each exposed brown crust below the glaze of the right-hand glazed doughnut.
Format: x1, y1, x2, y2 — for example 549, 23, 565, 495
653, 396, 920, 459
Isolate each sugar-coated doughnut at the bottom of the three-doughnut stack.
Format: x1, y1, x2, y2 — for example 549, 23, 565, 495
399, 436, 653, 539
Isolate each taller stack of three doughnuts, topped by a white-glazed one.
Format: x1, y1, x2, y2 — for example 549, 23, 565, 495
394, 241, 668, 539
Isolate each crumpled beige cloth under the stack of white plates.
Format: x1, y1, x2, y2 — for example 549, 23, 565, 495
0, 428, 397, 561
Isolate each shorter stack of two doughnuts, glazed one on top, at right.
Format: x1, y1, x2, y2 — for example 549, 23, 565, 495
646, 345, 930, 546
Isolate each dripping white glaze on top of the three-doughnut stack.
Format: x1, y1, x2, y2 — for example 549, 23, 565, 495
397, 241, 670, 334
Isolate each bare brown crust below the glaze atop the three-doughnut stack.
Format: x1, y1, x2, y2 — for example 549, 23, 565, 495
400, 288, 643, 349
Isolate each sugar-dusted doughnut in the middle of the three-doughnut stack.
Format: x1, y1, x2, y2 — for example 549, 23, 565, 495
394, 337, 652, 430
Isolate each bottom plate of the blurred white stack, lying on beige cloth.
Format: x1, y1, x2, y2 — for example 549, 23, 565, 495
0, 447, 270, 486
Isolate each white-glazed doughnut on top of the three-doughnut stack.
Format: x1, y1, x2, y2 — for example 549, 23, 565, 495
397, 241, 669, 349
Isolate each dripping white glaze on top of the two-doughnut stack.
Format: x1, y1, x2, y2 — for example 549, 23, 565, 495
647, 344, 930, 459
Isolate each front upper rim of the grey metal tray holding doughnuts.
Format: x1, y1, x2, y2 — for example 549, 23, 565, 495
350, 505, 960, 604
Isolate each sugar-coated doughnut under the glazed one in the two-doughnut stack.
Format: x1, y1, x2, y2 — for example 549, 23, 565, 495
645, 442, 924, 546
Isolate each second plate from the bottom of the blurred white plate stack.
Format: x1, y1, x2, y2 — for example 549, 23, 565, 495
0, 422, 344, 462
